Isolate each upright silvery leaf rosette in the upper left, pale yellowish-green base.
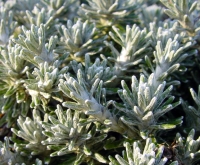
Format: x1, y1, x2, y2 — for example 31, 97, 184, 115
14, 24, 57, 66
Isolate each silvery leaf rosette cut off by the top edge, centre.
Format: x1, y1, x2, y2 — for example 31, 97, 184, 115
79, 0, 141, 26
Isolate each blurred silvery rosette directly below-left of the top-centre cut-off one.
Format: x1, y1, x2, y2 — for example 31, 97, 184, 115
57, 20, 106, 60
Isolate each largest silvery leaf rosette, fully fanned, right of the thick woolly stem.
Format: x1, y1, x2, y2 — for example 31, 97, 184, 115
112, 74, 182, 138
